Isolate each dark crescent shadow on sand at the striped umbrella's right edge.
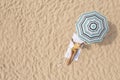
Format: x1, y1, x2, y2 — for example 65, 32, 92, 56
99, 21, 118, 46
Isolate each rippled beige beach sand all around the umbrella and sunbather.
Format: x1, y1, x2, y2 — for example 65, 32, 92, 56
0, 0, 120, 80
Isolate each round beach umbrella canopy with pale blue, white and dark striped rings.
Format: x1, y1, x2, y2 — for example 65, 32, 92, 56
76, 11, 108, 43
